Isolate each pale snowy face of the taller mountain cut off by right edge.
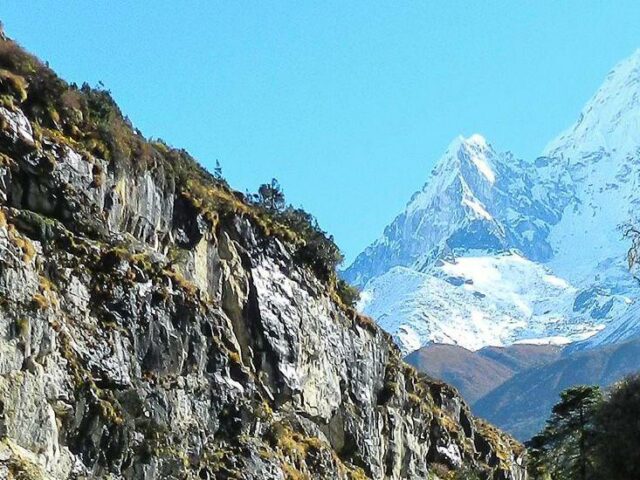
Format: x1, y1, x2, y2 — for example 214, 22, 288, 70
544, 51, 640, 289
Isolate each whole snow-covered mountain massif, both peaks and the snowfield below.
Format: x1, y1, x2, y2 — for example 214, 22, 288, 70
344, 51, 640, 352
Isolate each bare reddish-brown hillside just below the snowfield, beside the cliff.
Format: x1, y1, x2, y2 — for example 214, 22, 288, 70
405, 343, 560, 403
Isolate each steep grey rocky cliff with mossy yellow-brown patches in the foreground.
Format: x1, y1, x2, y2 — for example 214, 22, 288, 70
0, 34, 525, 480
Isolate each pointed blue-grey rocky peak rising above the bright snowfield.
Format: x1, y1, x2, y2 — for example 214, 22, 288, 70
343, 135, 556, 286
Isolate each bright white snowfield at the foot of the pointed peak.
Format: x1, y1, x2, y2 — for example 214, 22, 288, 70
359, 252, 600, 353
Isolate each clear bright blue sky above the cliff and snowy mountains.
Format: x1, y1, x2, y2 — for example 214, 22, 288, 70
0, 0, 640, 260
